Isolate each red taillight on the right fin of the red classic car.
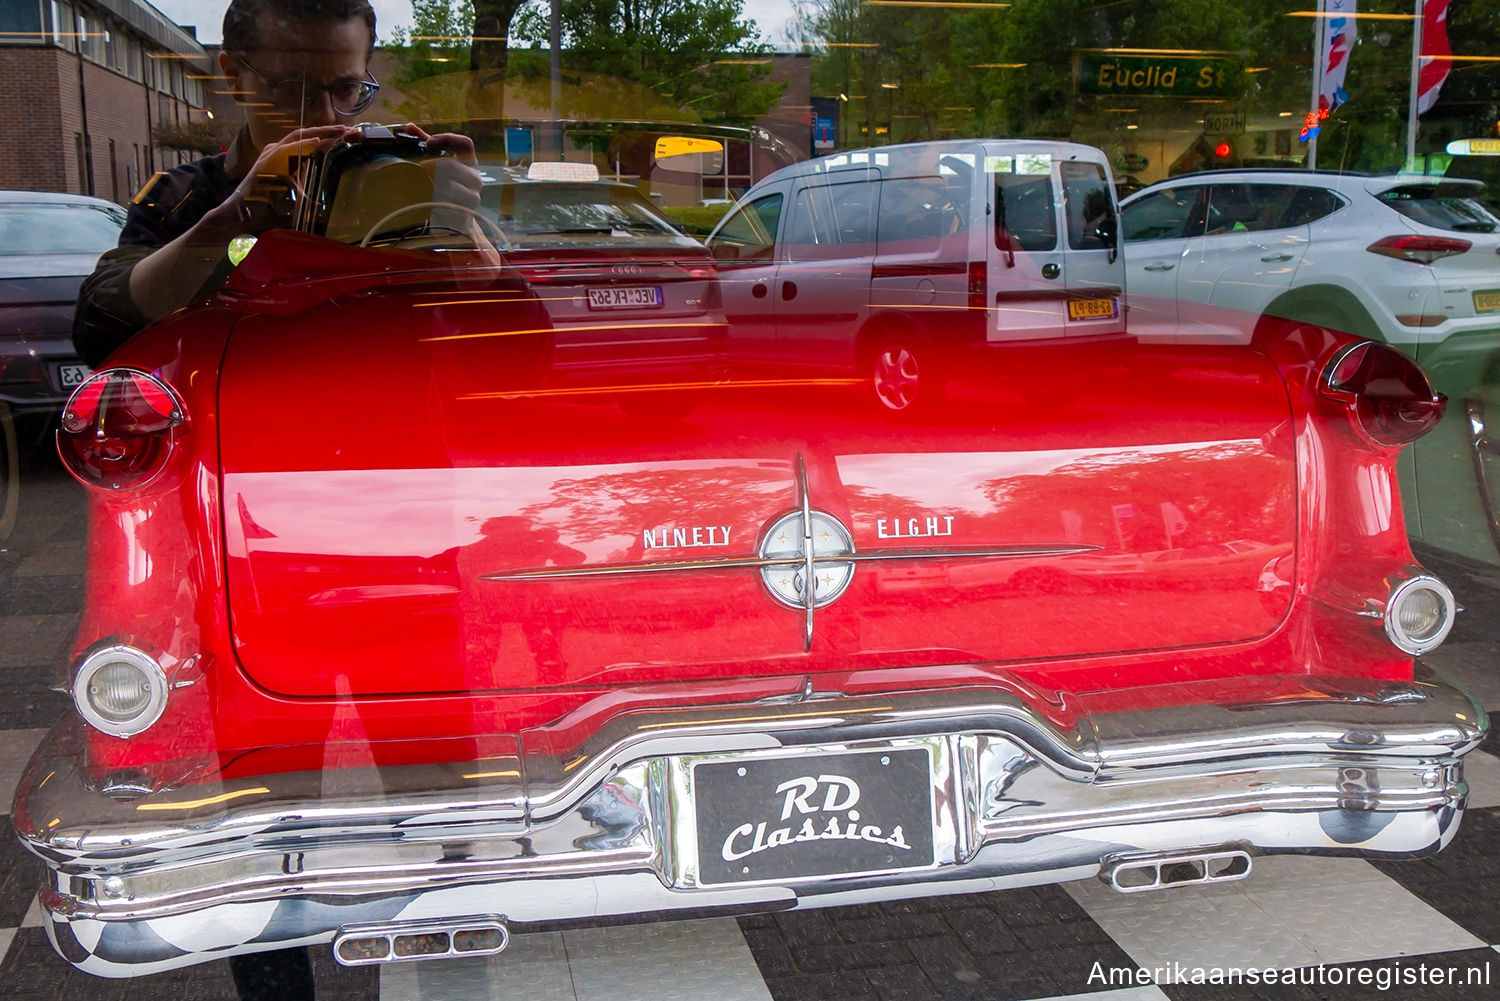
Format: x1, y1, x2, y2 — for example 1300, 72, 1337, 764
1323, 341, 1448, 446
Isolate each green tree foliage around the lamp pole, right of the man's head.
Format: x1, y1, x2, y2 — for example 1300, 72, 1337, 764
513, 0, 783, 122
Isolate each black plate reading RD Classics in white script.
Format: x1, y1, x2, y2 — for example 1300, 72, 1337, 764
693, 747, 933, 885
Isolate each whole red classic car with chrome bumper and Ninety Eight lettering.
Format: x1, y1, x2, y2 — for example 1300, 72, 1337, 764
14, 127, 1488, 977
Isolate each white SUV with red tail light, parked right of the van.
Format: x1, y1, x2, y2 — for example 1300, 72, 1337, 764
1121, 170, 1500, 356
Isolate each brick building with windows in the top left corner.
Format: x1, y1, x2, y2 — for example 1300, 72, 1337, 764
0, 0, 218, 203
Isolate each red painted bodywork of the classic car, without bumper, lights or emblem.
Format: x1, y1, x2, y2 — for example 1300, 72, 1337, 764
64, 223, 1434, 773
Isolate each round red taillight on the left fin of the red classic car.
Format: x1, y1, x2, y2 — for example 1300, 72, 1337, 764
57, 369, 188, 491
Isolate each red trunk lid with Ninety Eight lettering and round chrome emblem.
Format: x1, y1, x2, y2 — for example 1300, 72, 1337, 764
221, 279, 1296, 696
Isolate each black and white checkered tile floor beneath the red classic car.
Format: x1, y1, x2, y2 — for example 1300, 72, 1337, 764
0, 461, 1500, 1001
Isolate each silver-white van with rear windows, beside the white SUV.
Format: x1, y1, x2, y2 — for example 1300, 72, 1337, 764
707, 140, 1124, 413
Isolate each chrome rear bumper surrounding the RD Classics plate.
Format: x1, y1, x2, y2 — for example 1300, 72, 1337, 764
14, 677, 1488, 975
